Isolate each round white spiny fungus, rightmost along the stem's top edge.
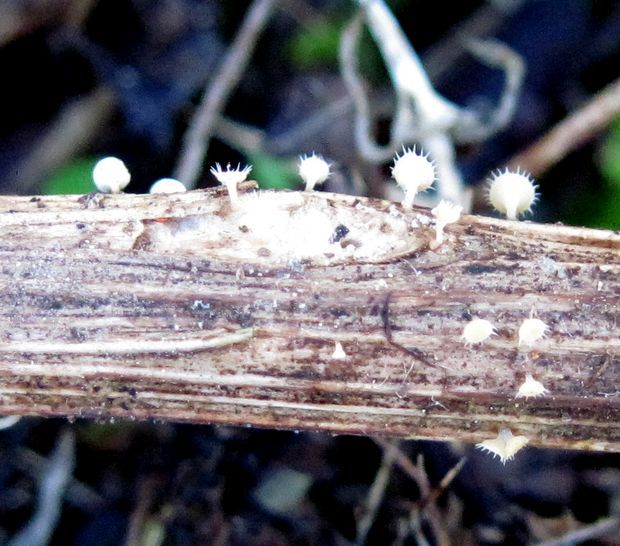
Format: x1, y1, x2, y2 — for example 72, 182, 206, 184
489, 169, 536, 220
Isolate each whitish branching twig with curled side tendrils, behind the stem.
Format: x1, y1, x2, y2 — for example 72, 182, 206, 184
340, 0, 524, 208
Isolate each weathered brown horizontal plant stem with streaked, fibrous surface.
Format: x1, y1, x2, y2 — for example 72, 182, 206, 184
0, 184, 620, 451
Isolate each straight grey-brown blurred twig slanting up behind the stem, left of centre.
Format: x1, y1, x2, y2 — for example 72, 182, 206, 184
174, 0, 278, 188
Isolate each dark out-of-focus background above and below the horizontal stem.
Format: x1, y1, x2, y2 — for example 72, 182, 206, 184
0, 0, 620, 546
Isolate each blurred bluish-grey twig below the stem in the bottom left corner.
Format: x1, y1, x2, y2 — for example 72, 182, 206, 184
8, 429, 75, 546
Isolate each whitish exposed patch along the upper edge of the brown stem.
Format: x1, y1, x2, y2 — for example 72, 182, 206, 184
140, 191, 428, 265
